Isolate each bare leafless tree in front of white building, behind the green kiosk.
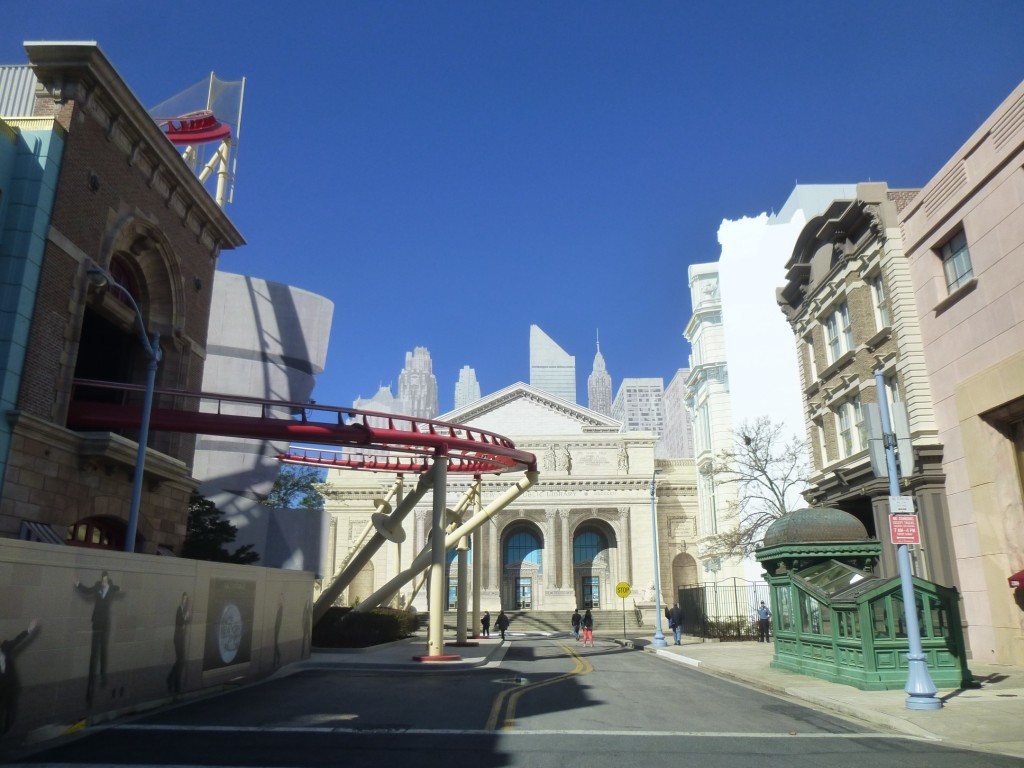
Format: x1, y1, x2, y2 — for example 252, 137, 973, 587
705, 416, 809, 557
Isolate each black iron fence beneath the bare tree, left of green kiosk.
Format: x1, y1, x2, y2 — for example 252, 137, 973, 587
679, 579, 770, 640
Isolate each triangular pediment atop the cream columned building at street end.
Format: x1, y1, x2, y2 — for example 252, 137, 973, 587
438, 382, 622, 438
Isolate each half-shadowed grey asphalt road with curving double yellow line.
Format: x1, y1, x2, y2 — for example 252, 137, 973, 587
6, 638, 1024, 768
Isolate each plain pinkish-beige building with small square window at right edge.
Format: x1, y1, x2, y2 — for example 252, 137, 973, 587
900, 83, 1024, 665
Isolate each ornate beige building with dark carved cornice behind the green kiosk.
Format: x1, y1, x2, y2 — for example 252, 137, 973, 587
778, 183, 956, 586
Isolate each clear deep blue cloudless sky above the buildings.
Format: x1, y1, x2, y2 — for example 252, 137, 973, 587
0, 0, 1024, 413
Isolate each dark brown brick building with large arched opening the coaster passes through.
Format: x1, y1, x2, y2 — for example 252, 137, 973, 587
0, 43, 244, 552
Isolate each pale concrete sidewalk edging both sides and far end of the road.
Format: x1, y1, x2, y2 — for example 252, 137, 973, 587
294, 632, 1024, 758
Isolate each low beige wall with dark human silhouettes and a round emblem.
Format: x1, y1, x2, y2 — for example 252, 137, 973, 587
0, 540, 312, 744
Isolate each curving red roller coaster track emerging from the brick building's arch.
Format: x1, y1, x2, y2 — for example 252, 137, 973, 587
68, 380, 537, 474
